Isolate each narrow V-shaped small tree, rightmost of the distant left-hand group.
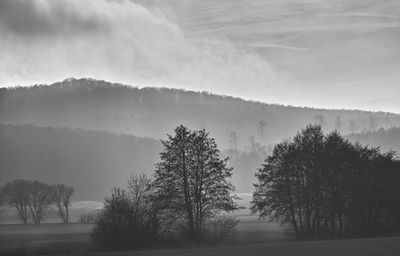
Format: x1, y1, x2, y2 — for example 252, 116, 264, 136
53, 184, 74, 223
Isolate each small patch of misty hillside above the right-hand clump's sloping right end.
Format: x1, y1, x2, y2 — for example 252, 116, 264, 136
346, 127, 400, 156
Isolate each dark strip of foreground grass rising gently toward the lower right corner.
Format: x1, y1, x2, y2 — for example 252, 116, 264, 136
88, 237, 400, 256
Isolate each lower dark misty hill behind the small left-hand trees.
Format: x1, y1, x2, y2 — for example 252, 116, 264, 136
0, 125, 161, 200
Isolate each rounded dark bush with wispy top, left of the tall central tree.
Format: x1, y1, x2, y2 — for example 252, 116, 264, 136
92, 175, 159, 249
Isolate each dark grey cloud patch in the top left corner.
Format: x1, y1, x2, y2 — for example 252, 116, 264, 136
0, 0, 107, 36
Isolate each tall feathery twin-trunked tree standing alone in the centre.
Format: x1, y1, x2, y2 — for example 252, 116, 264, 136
154, 125, 237, 241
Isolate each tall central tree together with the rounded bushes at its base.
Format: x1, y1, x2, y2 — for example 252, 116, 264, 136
92, 125, 238, 249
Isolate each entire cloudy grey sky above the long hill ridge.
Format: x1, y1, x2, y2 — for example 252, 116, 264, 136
0, 0, 400, 113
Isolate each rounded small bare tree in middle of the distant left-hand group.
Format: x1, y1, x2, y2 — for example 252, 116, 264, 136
28, 180, 53, 224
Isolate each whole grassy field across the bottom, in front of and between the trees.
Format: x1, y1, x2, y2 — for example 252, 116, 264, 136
0, 216, 400, 256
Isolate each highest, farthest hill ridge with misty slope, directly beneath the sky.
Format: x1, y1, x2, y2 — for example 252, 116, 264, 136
0, 79, 400, 148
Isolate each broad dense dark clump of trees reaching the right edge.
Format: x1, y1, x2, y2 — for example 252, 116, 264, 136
252, 126, 400, 239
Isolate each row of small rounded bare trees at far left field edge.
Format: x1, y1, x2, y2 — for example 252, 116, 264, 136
0, 179, 74, 224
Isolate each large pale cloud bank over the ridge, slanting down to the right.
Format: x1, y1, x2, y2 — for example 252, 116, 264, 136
0, 0, 286, 101
